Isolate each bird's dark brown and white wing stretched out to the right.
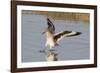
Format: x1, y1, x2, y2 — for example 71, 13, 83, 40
54, 31, 81, 42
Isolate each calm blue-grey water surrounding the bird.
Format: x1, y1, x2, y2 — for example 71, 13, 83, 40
22, 10, 90, 62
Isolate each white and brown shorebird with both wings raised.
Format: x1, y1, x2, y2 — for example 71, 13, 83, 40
43, 18, 81, 49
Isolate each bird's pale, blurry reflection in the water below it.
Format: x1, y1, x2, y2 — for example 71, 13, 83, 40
40, 50, 58, 62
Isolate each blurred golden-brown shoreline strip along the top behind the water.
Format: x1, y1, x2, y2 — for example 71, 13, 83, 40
22, 10, 90, 23
